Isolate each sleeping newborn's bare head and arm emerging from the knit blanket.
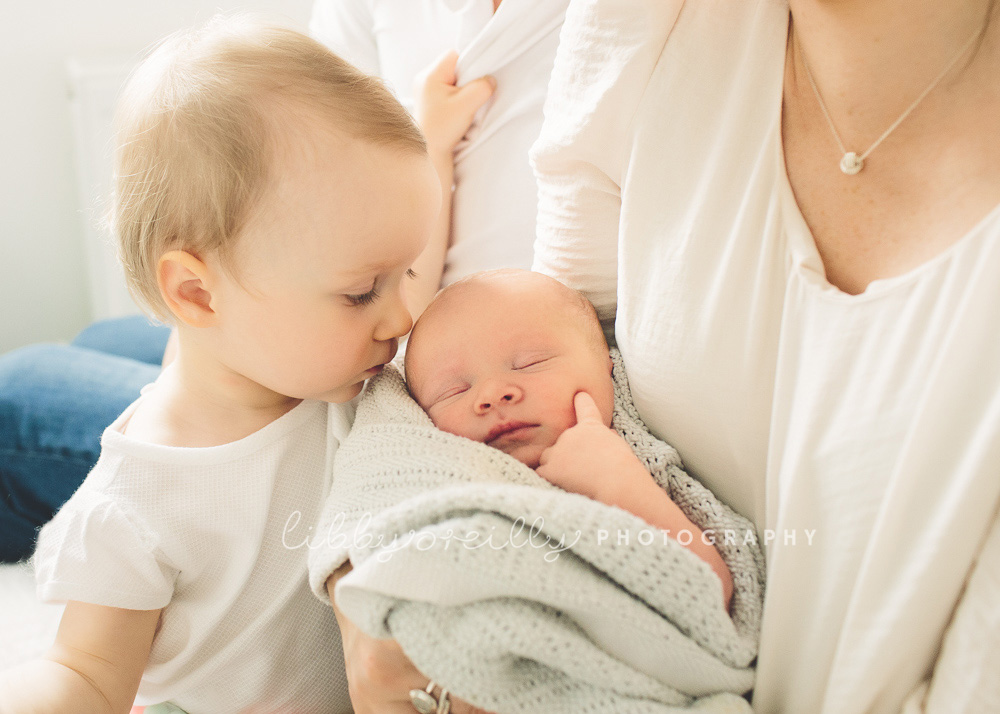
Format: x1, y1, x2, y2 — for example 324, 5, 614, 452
405, 270, 732, 607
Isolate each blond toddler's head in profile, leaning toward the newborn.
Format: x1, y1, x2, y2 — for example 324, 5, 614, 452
112, 17, 440, 401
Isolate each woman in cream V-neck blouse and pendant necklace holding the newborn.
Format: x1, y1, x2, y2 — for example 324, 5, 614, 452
342, 0, 1000, 714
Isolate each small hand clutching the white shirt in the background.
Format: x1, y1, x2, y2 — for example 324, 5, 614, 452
416, 51, 496, 156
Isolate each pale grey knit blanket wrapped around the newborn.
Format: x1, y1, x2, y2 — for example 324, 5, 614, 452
309, 351, 764, 714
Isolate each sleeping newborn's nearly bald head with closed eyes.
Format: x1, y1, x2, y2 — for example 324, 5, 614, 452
406, 270, 614, 468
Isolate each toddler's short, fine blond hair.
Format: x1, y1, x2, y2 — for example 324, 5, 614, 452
110, 15, 427, 322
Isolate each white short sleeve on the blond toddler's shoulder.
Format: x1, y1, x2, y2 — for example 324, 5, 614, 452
33, 492, 177, 610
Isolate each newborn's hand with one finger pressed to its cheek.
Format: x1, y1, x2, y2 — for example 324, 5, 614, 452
536, 392, 653, 505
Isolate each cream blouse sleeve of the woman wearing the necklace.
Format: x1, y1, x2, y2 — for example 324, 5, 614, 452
531, 0, 683, 332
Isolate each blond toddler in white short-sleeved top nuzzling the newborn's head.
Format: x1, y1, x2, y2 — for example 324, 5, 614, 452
0, 18, 476, 714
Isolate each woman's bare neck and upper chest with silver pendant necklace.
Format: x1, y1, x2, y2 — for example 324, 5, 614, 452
781, 0, 1000, 294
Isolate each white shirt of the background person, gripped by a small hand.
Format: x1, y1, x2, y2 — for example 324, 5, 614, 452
309, 0, 568, 285
